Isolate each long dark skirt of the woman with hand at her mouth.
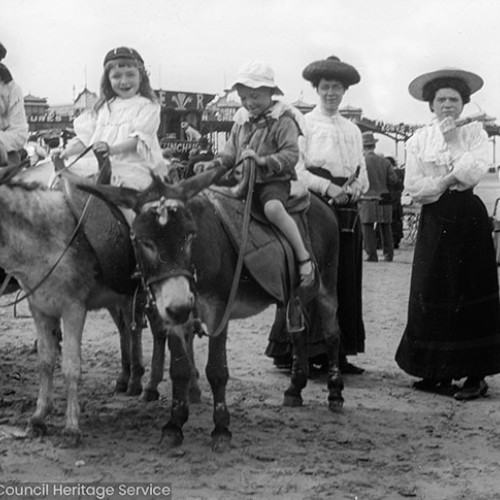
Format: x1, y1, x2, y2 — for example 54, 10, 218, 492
396, 190, 500, 379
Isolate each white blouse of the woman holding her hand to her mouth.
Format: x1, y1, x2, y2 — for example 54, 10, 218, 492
405, 119, 489, 204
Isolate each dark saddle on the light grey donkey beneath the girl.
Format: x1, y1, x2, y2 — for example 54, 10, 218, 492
56, 160, 137, 294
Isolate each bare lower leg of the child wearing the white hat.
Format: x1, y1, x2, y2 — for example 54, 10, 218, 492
264, 200, 314, 286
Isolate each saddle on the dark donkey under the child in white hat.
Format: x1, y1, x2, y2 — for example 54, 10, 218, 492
202, 186, 319, 305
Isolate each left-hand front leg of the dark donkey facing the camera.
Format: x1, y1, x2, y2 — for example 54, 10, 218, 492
162, 325, 191, 447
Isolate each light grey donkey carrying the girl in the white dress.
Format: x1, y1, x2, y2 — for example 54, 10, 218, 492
0, 163, 185, 446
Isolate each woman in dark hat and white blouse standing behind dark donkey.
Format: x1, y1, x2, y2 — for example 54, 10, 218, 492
297, 56, 369, 374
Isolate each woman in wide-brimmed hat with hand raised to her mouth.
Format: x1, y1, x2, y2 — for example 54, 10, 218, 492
396, 69, 500, 400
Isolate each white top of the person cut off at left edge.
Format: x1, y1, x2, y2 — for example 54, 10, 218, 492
0, 81, 28, 151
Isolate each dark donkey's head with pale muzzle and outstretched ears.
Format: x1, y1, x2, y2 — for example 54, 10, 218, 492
79, 169, 225, 325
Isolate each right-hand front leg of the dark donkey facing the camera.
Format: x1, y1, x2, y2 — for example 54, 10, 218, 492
206, 325, 232, 451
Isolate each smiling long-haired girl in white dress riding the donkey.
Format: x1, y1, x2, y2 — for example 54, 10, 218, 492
60, 47, 164, 190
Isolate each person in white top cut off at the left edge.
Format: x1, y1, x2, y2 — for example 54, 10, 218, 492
0, 43, 28, 166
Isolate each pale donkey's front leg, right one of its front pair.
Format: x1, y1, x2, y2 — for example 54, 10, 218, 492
62, 304, 87, 446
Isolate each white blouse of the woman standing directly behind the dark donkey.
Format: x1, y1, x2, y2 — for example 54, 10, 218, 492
297, 106, 369, 195
